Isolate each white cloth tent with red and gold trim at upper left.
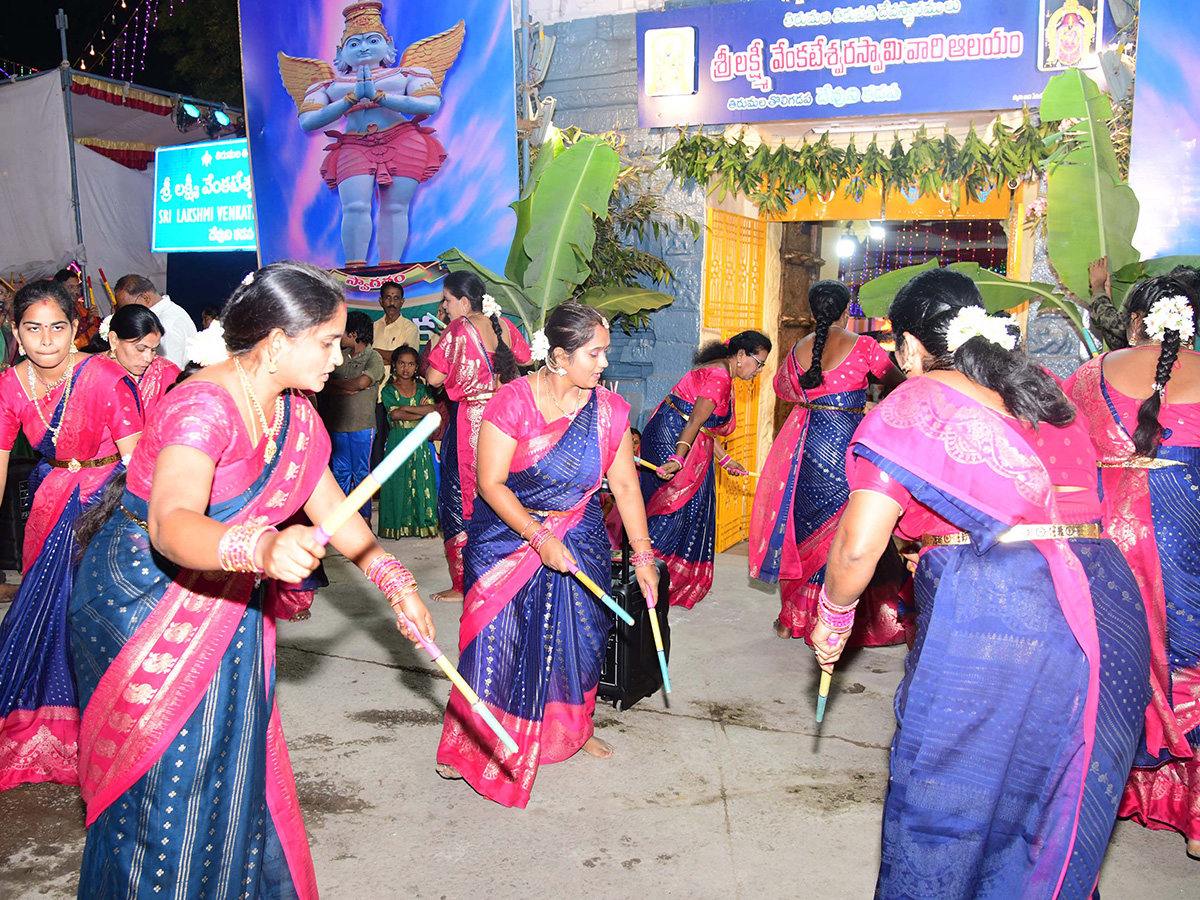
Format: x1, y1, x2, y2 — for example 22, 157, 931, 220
0, 70, 231, 308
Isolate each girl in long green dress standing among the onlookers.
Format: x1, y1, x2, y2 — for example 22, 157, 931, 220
379, 344, 438, 538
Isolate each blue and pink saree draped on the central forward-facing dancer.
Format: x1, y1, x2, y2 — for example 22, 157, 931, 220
438, 383, 629, 808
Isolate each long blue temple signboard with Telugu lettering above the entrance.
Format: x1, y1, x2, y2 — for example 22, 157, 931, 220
637, 0, 1110, 127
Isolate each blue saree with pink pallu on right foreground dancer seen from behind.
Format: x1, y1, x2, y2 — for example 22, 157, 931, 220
850, 378, 1123, 899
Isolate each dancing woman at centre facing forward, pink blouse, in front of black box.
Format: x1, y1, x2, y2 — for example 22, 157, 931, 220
438, 302, 659, 808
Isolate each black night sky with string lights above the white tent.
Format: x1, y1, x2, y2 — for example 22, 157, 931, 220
0, 0, 208, 94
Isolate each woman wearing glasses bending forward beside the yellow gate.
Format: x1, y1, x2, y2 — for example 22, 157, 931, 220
640, 331, 770, 610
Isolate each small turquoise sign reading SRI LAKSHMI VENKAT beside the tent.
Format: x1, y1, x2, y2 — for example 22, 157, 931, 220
151, 138, 258, 253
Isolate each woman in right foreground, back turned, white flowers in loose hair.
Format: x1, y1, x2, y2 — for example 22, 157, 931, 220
812, 269, 1150, 900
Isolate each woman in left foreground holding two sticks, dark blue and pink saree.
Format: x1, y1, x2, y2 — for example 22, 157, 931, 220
71, 263, 433, 900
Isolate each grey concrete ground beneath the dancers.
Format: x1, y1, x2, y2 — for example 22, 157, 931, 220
0, 540, 1200, 900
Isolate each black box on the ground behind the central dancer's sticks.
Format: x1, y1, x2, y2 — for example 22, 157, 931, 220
596, 541, 671, 709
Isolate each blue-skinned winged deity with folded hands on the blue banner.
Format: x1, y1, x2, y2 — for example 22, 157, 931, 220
278, 0, 467, 269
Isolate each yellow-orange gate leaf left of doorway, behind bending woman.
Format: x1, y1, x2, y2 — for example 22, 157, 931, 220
703, 209, 767, 553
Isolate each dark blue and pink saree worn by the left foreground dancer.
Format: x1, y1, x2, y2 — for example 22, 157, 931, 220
72, 396, 329, 900
